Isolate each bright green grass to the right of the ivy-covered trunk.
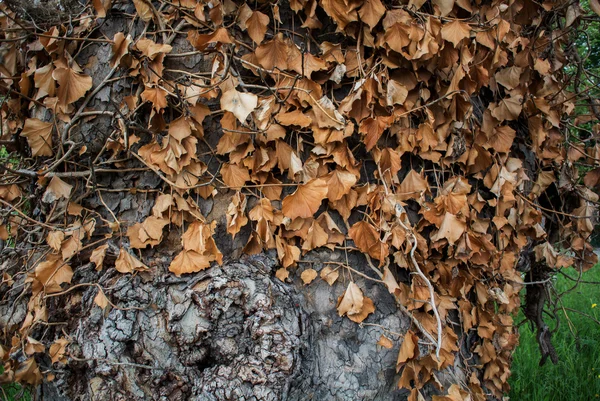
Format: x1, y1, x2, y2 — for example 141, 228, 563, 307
509, 266, 600, 401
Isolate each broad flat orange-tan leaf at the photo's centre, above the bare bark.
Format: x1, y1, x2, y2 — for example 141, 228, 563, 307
281, 179, 328, 220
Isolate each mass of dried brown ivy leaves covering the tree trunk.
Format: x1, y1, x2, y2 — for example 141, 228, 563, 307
0, 0, 600, 401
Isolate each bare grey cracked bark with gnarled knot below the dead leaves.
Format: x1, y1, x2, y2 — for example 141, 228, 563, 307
35, 255, 408, 401
